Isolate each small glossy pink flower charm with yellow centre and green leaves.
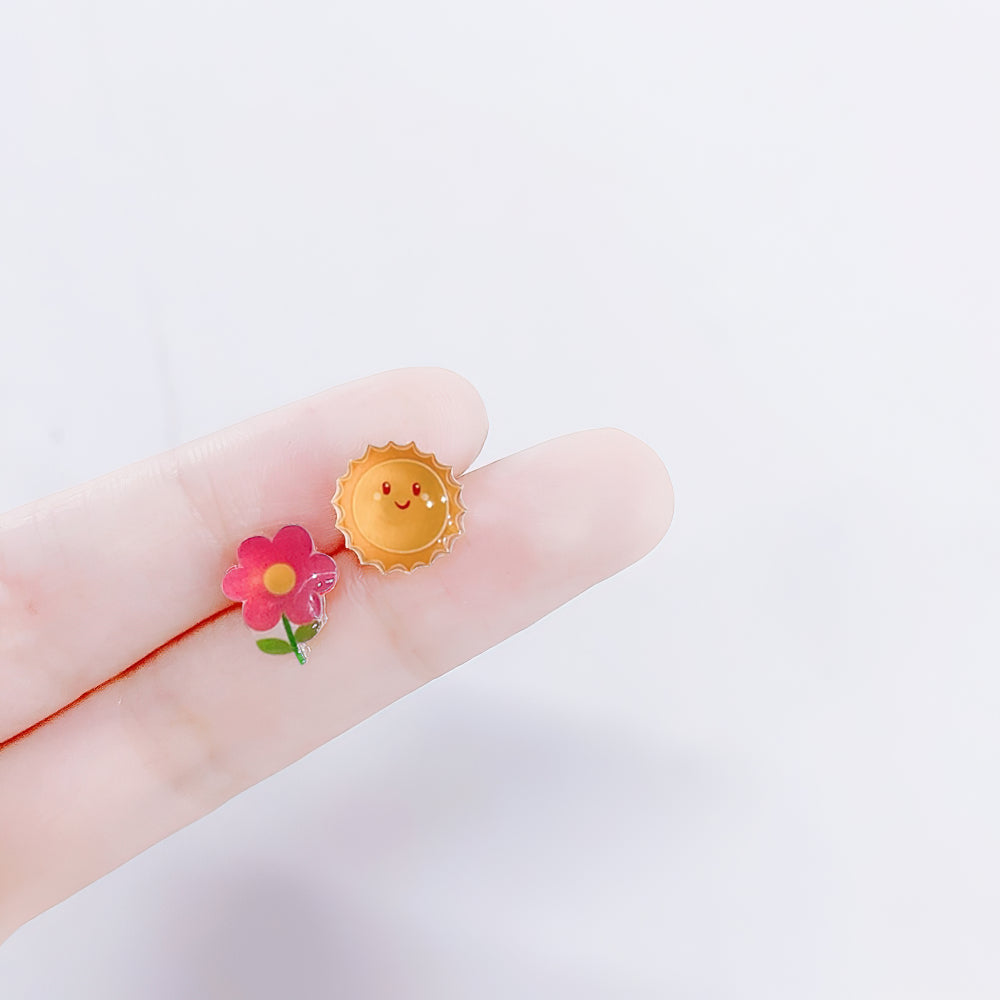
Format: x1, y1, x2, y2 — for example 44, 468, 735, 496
222, 524, 337, 663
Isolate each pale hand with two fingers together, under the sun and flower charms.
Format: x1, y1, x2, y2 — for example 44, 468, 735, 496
0, 369, 673, 939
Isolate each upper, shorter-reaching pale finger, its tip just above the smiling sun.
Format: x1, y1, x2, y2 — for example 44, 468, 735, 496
0, 369, 487, 741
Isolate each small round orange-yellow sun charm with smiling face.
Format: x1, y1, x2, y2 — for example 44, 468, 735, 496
331, 441, 465, 573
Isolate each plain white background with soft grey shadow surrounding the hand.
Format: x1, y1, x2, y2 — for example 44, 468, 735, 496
0, 0, 1000, 1000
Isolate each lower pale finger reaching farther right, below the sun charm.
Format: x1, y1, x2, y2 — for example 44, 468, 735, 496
0, 431, 672, 928
